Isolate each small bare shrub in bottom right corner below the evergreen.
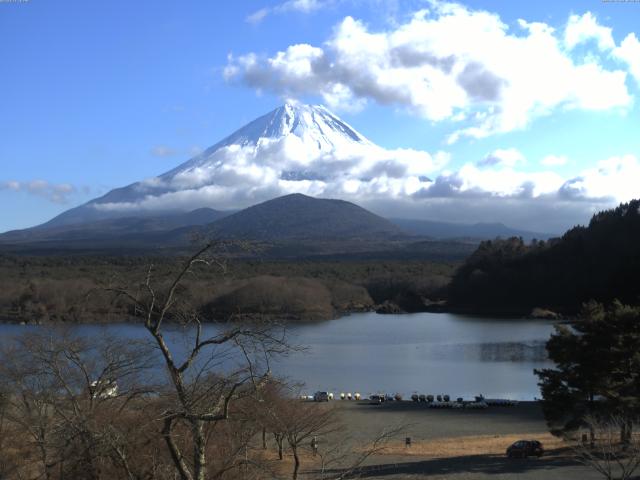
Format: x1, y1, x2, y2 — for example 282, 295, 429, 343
574, 415, 640, 480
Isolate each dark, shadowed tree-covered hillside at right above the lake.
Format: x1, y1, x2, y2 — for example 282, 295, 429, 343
449, 200, 640, 314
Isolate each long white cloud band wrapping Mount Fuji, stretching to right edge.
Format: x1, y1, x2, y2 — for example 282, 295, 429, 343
90, 135, 640, 232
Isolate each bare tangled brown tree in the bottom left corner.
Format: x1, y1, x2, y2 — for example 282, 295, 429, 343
0, 331, 156, 479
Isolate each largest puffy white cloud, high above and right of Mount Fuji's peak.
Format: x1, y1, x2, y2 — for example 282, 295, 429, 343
225, 2, 635, 143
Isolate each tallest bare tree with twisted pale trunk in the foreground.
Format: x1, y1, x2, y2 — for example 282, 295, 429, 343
109, 244, 287, 480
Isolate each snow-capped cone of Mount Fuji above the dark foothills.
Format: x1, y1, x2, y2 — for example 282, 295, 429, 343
42, 103, 385, 227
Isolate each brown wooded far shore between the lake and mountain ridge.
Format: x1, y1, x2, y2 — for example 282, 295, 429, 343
0, 255, 456, 323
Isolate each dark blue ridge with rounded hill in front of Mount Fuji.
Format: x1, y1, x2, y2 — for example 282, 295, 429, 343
0, 194, 548, 248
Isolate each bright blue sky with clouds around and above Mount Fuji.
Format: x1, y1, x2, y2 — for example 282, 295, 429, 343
0, 0, 640, 231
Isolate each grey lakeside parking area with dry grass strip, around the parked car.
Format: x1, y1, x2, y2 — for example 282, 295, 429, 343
320, 400, 601, 480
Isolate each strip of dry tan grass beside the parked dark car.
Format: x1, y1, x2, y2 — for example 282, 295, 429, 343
380, 433, 568, 458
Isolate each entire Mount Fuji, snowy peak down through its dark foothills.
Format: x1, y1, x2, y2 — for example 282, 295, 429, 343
0, 103, 552, 248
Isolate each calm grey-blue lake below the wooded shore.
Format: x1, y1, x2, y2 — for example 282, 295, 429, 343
0, 313, 553, 400
